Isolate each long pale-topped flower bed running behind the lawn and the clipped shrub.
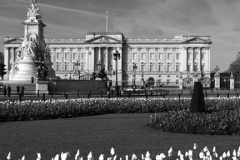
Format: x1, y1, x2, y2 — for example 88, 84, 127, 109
0, 98, 240, 125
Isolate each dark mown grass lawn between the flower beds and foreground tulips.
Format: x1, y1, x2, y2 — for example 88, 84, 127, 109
0, 114, 240, 160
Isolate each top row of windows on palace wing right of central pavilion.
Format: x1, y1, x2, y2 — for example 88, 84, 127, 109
133, 52, 205, 60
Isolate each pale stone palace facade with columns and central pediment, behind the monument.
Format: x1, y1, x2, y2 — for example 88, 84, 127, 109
4, 32, 212, 85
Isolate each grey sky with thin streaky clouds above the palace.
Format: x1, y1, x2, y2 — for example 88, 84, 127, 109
0, 0, 240, 71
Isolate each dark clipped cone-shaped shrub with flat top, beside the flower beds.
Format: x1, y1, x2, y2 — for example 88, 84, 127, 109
190, 82, 206, 113
